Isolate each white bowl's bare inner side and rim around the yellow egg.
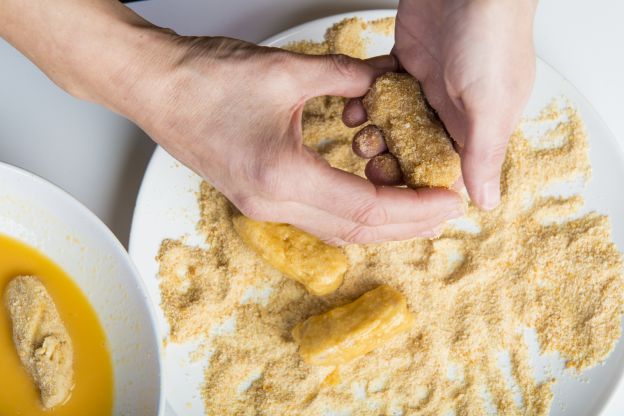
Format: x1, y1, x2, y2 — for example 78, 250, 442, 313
0, 163, 163, 415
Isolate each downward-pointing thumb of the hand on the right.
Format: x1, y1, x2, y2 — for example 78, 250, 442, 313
461, 117, 511, 210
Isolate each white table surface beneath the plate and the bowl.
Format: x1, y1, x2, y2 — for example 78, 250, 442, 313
0, 0, 624, 416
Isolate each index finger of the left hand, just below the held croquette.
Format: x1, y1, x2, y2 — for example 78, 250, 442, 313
285, 156, 464, 226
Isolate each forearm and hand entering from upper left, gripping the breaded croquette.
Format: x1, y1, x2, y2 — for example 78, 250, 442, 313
0, 0, 462, 243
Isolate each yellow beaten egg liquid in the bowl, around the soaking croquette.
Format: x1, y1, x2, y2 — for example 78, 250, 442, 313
0, 235, 113, 416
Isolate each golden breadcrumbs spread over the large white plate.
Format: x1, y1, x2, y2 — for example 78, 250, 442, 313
158, 19, 624, 415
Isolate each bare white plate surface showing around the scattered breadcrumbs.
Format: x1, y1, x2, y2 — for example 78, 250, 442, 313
130, 10, 624, 416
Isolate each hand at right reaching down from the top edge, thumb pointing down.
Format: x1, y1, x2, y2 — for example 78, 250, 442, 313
344, 0, 536, 209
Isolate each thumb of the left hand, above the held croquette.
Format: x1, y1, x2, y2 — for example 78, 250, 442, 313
298, 54, 398, 97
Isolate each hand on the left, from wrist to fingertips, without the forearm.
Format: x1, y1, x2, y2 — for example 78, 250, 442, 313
133, 37, 462, 244
